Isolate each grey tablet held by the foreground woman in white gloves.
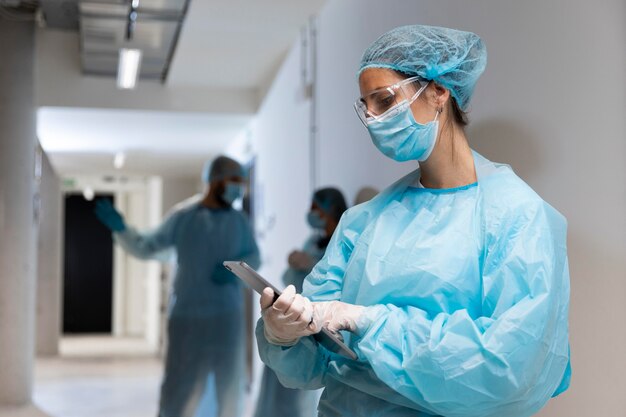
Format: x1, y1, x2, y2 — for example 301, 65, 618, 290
224, 261, 357, 360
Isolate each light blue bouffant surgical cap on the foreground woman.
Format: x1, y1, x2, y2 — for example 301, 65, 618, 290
359, 25, 487, 110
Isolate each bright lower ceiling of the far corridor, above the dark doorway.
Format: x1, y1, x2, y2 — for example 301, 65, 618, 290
37, 107, 250, 177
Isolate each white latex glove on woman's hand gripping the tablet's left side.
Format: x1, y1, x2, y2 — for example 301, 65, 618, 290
261, 285, 319, 346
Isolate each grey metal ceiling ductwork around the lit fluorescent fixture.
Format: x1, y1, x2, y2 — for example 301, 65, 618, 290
39, 0, 189, 81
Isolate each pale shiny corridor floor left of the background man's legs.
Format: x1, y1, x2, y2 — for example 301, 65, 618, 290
33, 338, 162, 417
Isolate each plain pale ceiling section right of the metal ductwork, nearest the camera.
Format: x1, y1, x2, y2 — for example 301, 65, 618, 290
167, 0, 326, 89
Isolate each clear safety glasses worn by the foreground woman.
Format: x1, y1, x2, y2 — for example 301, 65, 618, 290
354, 77, 428, 127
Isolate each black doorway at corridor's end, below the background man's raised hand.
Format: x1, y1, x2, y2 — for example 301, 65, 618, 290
63, 194, 113, 333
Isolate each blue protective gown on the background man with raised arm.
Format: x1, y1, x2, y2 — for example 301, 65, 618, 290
115, 203, 260, 417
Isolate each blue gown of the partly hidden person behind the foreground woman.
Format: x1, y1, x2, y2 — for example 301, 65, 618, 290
254, 235, 325, 417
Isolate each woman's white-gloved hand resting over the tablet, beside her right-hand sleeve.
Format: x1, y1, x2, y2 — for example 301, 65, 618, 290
309, 301, 366, 334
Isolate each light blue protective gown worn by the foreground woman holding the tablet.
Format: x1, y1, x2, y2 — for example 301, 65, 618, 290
257, 153, 571, 417
